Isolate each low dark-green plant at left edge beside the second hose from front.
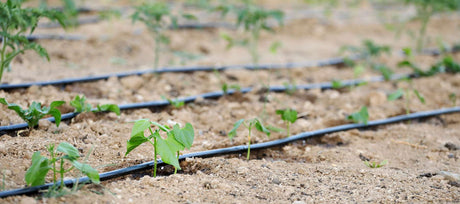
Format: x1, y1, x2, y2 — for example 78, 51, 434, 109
0, 98, 65, 129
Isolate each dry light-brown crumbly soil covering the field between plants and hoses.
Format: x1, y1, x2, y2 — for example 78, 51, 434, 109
0, 1, 460, 203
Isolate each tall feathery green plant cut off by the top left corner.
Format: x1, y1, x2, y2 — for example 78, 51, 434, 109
0, 0, 65, 82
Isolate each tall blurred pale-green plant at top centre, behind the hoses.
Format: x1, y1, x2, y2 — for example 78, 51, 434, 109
216, 0, 284, 64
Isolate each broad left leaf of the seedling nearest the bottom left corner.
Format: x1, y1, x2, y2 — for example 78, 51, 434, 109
25, 151, 52, 186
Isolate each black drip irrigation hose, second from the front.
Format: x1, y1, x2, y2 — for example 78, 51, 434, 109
0, 75, 406, 135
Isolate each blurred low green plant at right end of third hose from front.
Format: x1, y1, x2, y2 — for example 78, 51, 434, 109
340, 40, 393, 80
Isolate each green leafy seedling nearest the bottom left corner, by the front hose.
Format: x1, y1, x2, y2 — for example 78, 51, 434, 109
25, 142, 100, 194
